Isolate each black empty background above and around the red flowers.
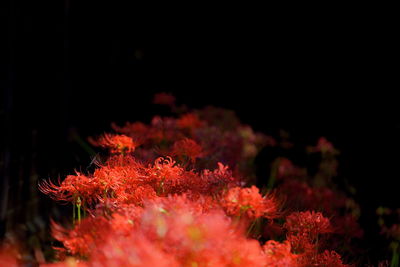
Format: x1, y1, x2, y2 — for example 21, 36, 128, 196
0, 1, 400, 264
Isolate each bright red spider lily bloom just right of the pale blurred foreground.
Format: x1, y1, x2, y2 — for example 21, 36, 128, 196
222, 186, 278, 219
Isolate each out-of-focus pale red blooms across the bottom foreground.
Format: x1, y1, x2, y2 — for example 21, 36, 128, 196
53, 196, 265, 266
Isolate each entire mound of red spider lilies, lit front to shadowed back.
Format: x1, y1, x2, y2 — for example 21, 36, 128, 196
3, 94, 351, 267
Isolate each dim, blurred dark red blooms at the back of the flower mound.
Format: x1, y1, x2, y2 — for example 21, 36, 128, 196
106, 94, 275, 181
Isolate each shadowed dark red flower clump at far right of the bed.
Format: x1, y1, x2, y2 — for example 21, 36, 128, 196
258, 136, 363, 262
